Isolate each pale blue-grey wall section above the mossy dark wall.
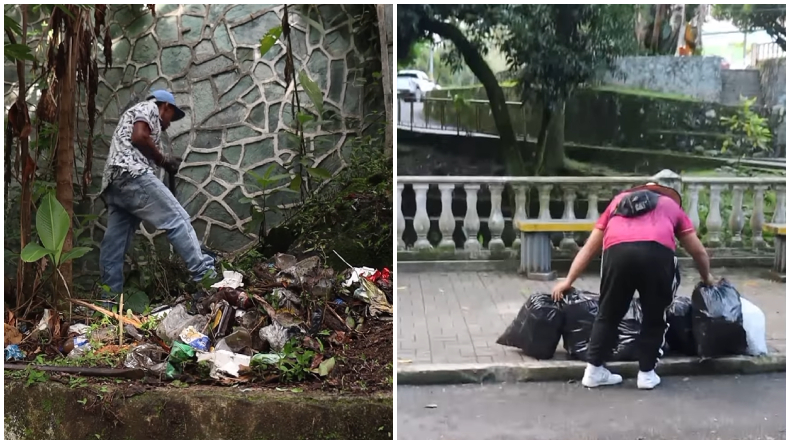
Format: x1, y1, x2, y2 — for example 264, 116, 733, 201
602, 56, 722, 102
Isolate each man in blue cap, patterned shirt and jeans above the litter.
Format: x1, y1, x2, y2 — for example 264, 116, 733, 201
99, 90, 216, 296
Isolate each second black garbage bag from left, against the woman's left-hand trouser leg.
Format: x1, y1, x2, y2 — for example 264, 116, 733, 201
562, 290, 598, 361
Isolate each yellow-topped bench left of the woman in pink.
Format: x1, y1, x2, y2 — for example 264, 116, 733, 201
516, 219, 595, 281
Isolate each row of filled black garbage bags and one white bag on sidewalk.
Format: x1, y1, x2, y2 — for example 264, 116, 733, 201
497, 279, 768, 361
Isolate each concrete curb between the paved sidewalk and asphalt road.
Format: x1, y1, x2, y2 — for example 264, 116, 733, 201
397, 353, 786, 385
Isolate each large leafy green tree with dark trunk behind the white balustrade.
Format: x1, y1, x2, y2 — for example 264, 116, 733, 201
398, 4, 638, 174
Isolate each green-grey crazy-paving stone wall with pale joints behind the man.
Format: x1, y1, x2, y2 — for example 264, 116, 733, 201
86, 5, 375, 255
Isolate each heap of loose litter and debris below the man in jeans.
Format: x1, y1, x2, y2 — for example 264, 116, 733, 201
4, 254, 393, 381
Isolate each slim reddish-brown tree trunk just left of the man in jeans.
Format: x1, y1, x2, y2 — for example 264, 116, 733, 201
55, 25, 82, 300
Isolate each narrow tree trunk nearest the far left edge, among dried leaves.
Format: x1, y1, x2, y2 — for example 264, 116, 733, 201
9, 5, 36, 308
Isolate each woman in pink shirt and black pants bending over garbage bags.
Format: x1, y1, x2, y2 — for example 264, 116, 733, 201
552, 183, 714, 389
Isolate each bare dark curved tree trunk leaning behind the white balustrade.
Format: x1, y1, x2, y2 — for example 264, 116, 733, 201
419, 18, 526, 175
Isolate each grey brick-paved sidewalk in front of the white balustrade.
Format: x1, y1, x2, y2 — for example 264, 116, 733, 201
397, 269, 786, 364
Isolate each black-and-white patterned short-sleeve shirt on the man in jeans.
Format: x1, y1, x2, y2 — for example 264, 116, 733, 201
101, 101, 162, 193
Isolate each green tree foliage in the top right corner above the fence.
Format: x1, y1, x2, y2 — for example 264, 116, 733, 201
713, 5, 787, 51
